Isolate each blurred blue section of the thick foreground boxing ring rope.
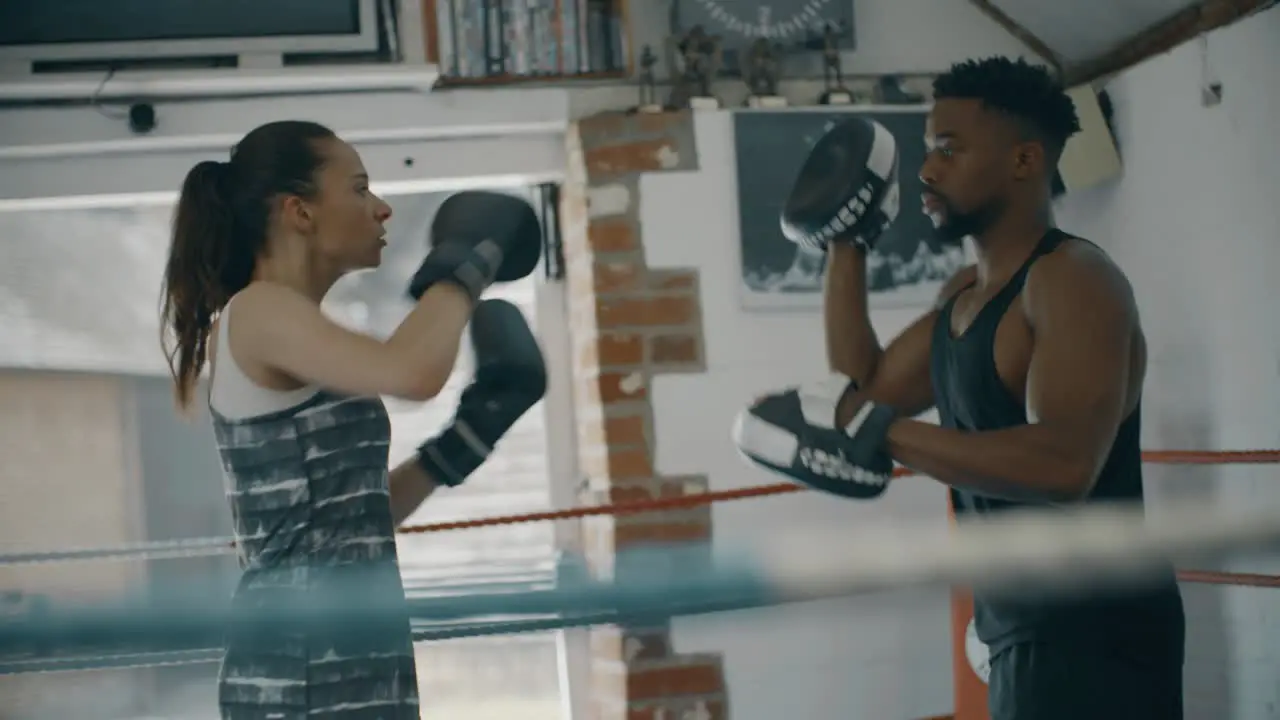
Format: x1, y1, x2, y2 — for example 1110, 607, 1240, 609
0, 551, 771, 675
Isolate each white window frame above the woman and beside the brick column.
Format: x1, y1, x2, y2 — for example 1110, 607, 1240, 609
0, 83, 590, 720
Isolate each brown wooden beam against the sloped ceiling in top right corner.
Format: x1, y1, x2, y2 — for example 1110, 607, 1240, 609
1065, 0, 1277, 87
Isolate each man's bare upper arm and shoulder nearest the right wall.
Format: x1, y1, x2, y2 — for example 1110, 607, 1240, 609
1025, 259, 1137, 458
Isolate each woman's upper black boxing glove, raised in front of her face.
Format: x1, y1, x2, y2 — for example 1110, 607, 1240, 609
408, 191, 543, 301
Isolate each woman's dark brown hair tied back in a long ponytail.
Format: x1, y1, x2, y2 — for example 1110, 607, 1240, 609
160, 120, 334, 410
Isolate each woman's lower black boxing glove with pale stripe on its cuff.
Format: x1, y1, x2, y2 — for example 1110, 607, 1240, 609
417, 300, 547, 487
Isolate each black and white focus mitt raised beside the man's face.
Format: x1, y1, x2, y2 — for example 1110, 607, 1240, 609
780, 117, 900, 251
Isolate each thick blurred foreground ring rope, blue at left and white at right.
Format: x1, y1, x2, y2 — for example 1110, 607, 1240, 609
0, 502, 1280, 671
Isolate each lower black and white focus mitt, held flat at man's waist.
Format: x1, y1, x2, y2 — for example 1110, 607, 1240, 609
733, 373, 896, 500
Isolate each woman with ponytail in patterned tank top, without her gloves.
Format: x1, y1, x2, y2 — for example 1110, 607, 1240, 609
161, 122, 522, 720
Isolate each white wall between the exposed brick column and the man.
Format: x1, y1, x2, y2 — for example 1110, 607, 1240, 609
640, 106, 951, 720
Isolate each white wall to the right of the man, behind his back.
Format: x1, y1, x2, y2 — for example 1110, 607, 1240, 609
1057, 9, 1280, 720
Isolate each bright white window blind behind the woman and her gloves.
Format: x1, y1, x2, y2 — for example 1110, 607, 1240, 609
0, 193, 554, 592
